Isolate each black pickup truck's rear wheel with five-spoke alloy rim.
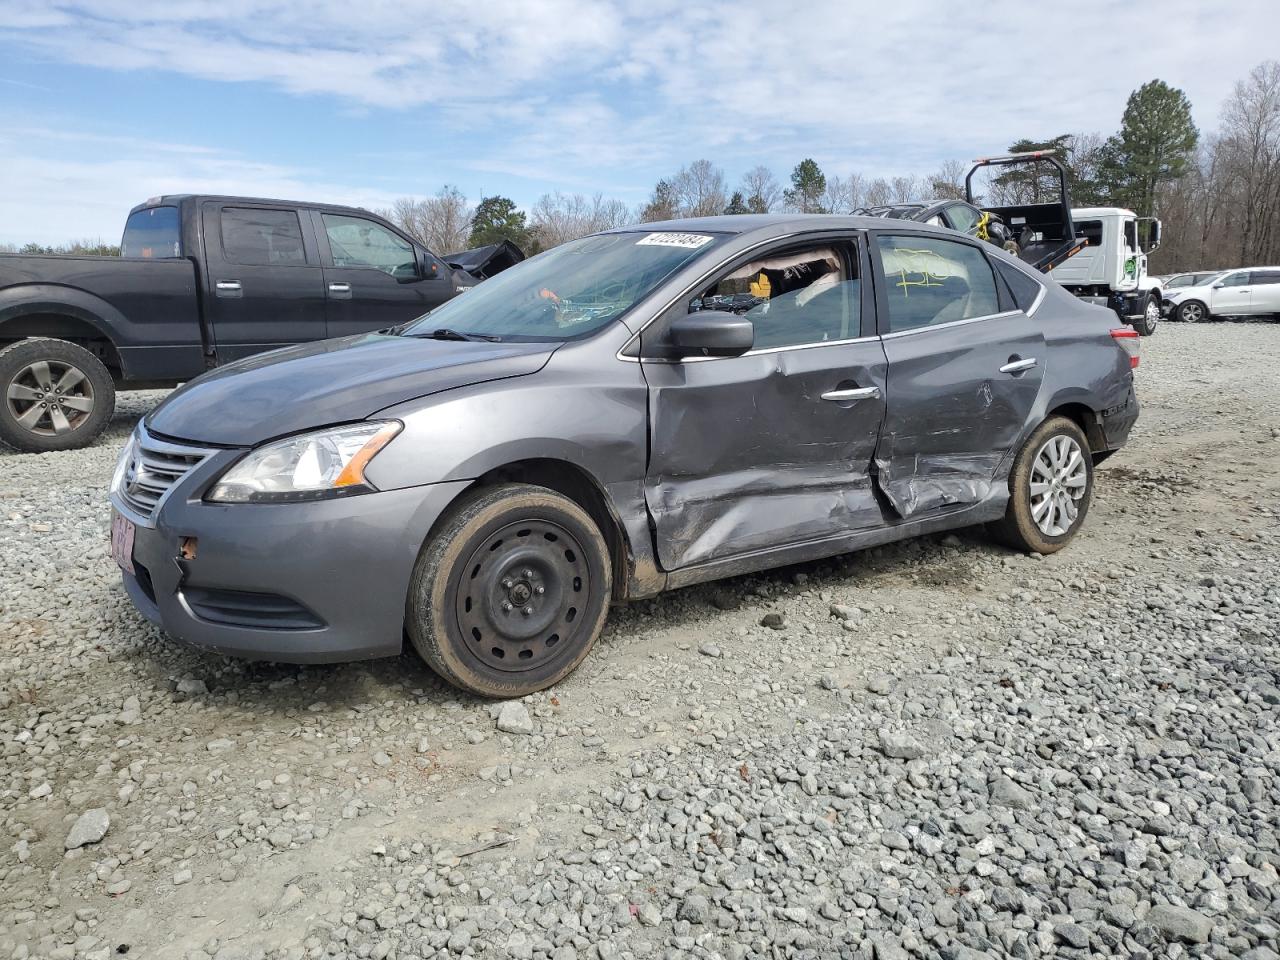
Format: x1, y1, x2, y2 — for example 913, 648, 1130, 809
0, 337, 115, 453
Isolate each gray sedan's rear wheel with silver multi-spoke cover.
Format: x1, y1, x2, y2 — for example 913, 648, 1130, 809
989, 416, 1093, 553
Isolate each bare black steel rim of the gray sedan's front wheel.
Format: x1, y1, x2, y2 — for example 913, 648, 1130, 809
454, 520, 591, 673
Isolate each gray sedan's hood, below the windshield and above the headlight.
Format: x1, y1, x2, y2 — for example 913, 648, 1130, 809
146, 334, 559, 447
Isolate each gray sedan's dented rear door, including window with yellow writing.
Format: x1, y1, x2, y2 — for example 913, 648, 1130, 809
873, 233, 1047, 520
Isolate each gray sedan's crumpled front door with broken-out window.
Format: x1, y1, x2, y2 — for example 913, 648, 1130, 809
641, 237, 884, 570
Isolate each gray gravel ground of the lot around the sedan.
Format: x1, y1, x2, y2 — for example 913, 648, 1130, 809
0, 323, 1280, 960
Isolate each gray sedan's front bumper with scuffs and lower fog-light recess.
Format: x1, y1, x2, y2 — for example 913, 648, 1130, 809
111, 435, 467, 663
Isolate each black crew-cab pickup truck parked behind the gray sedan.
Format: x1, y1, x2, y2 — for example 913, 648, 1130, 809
0, 195, 522, 452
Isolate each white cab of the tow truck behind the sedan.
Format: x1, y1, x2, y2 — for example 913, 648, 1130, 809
1048, 206, 1162, 335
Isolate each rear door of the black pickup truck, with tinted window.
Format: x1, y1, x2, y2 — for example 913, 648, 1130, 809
201, 200, 325, 364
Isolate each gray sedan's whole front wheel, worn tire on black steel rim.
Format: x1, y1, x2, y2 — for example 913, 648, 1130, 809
406, 484, 612, 699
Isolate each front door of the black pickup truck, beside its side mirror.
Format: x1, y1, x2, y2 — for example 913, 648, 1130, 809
312, 210, 454, 337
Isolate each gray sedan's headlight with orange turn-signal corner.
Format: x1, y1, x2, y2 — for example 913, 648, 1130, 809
205, 420, 401, 503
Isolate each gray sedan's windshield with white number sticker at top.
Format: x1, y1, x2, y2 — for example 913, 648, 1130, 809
404, 232, 723, 340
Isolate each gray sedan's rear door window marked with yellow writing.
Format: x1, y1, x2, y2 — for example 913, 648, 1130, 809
876, 236, 1000, 333
